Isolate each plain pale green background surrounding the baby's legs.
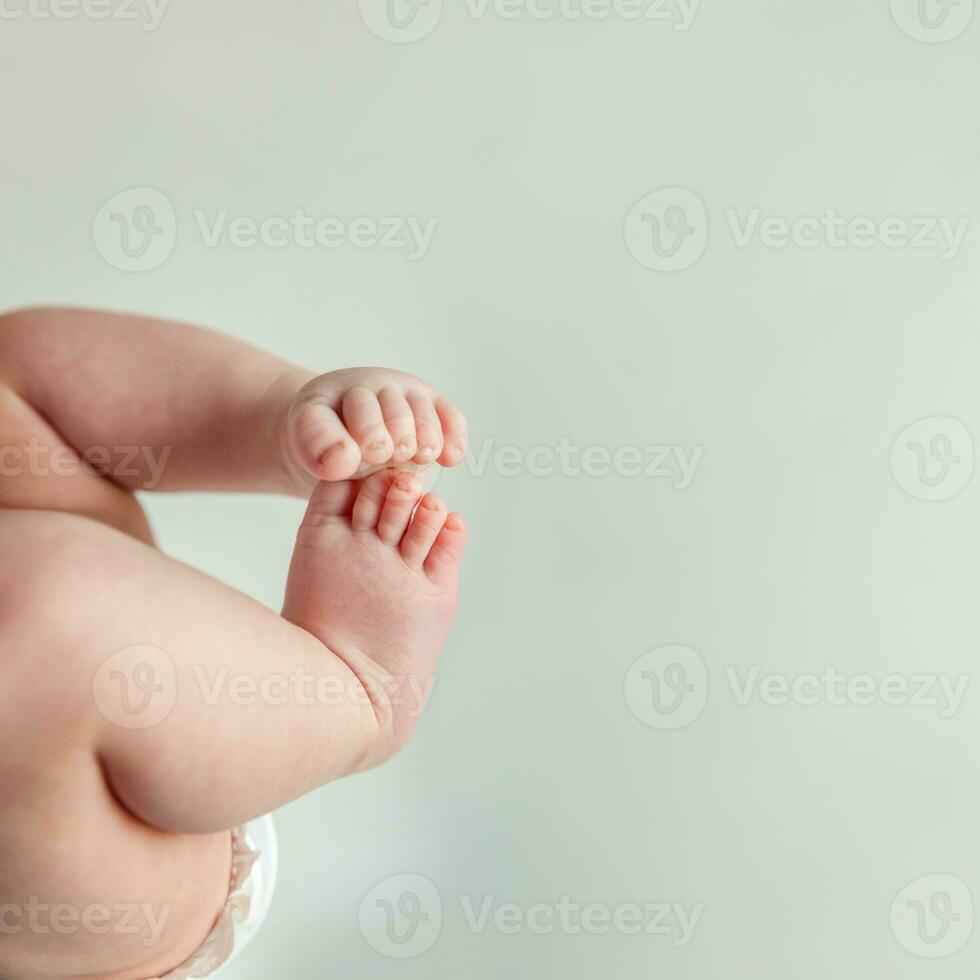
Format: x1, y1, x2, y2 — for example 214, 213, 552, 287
0, 0, 980, 980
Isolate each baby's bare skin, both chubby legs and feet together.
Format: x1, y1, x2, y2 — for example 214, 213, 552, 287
0, 310, 466, 980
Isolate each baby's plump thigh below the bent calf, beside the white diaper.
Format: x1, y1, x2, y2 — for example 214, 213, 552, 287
0, 700, 231, 980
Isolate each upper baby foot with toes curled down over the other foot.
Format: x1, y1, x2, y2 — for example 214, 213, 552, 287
285, 368, 466, 491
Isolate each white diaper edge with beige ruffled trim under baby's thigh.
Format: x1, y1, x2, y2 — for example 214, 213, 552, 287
160, 816, 279, 980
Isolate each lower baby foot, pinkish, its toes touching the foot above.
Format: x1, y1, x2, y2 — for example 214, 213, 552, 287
283, 470, 467, 765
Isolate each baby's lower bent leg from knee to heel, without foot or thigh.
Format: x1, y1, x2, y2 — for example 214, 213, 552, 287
0, 511, 380, 833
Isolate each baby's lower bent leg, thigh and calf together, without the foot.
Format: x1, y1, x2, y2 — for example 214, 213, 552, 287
0, 510, 378, 980
